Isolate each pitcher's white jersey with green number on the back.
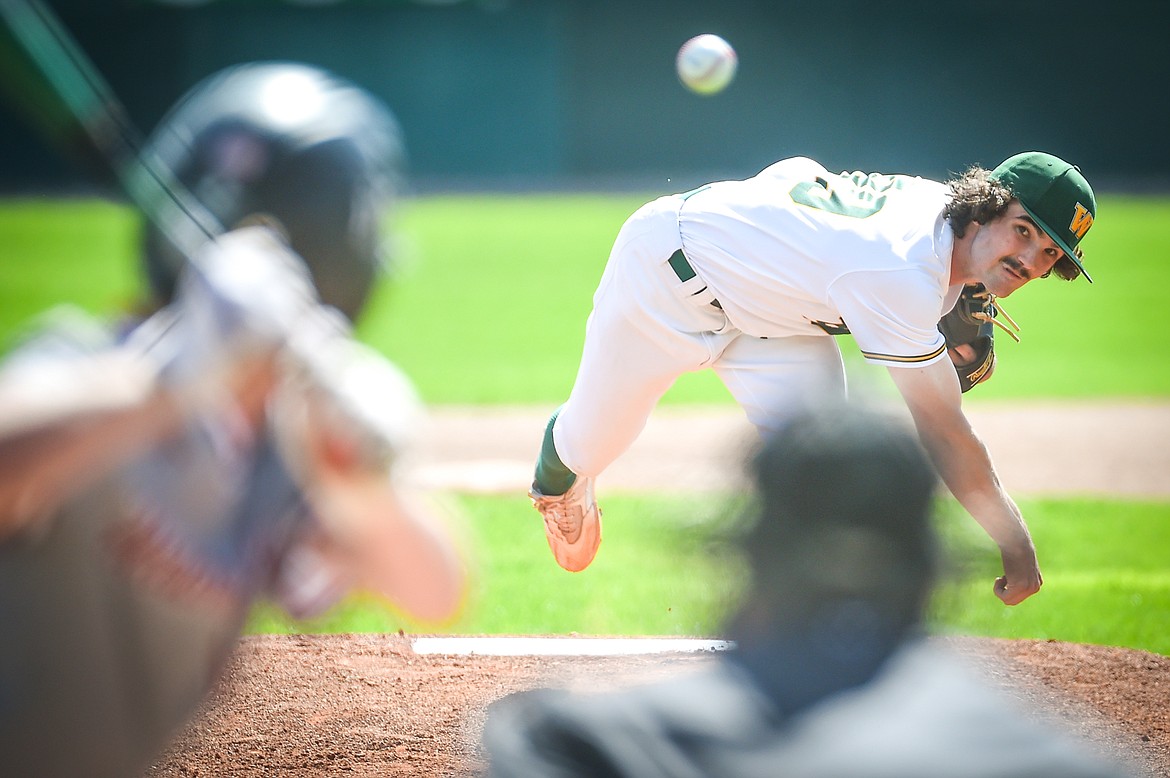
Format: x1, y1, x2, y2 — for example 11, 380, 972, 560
679, 157, 961, 366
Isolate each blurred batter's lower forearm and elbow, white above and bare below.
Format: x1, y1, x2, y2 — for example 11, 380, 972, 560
270, 328, 466, 621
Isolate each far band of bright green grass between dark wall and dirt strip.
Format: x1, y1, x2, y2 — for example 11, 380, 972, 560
0, 193, 1170, 406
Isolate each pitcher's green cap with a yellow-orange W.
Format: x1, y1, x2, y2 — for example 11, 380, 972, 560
991, 151, 1096, 283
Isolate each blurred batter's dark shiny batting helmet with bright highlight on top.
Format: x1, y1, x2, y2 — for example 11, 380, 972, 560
144, 62, 405, 319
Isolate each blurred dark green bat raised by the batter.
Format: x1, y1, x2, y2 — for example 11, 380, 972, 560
0, 0, 223, 265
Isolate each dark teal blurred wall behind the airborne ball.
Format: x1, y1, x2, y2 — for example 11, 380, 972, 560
0, 0, 1170, 192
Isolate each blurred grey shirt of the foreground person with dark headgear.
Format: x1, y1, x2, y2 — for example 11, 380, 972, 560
484, 645, 1129, 778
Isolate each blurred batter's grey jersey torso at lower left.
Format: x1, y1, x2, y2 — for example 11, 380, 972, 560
0, 311, 307, 778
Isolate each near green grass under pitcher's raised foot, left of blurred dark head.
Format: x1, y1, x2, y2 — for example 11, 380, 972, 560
249, 495, 742, 635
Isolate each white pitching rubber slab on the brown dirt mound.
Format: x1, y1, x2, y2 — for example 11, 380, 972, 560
411, 638, 734, 656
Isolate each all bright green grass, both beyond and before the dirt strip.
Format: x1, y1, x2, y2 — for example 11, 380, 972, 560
0, 194, 1170, 654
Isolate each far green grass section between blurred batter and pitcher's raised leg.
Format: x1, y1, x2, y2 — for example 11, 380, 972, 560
360, 195, 642, 404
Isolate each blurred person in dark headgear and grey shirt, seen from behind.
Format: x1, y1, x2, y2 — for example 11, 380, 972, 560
483, 401, 1130, 778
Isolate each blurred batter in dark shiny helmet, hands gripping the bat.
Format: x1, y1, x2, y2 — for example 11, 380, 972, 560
0, 63, 464, 777
